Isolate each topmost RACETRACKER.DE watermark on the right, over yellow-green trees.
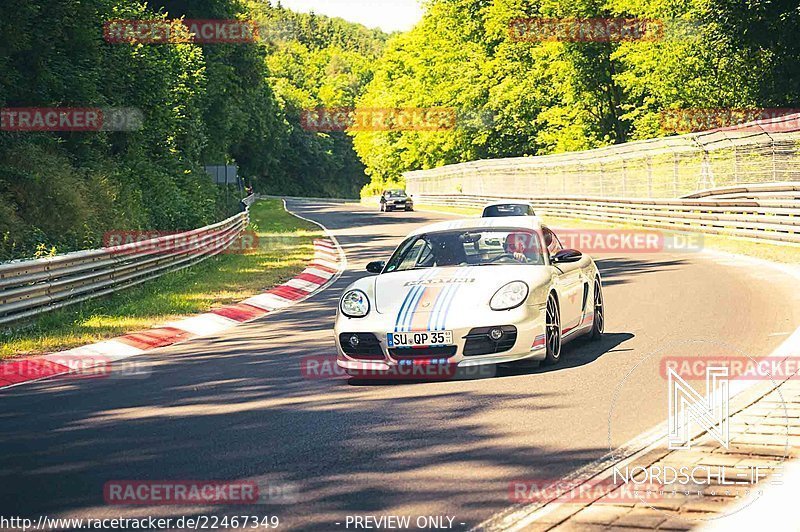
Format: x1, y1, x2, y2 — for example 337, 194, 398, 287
509, 18, 664, 42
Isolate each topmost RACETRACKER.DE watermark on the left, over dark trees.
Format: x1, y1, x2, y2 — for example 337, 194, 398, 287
103, 19, 258, 44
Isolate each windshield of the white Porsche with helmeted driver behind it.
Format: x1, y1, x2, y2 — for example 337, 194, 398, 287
384, 229, 544, 273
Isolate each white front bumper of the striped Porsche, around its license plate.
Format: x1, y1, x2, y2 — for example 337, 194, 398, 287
334, 305, 545, 376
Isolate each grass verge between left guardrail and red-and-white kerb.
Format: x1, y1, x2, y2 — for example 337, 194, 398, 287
0, 199, 322, 358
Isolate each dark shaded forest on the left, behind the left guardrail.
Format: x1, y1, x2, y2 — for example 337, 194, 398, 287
0, 0, 387, 260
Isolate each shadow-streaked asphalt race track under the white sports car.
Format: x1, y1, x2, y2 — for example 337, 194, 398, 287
0, 202, 800, 530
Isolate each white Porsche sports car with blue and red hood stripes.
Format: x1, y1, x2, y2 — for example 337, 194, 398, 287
334, 217, 604, 377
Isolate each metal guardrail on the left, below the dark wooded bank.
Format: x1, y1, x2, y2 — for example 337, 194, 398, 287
0, 195, 255, 325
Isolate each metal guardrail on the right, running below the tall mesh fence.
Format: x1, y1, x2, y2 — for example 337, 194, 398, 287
416, 183, 800, 244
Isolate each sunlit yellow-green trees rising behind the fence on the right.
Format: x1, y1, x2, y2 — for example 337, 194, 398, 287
354, 0, 800, 193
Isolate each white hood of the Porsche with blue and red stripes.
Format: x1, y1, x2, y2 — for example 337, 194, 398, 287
374, 265, 549, 318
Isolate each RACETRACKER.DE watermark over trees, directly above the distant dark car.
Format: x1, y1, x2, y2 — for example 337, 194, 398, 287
300, 107, 458, 132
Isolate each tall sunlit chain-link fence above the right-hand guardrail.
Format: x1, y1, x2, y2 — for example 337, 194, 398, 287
405, 113, 800, 198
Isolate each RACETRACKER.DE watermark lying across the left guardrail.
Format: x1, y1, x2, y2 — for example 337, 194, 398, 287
103, 230, 259, 255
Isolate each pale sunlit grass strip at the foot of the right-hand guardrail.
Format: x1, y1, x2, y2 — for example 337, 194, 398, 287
416, 205, 800, 264
